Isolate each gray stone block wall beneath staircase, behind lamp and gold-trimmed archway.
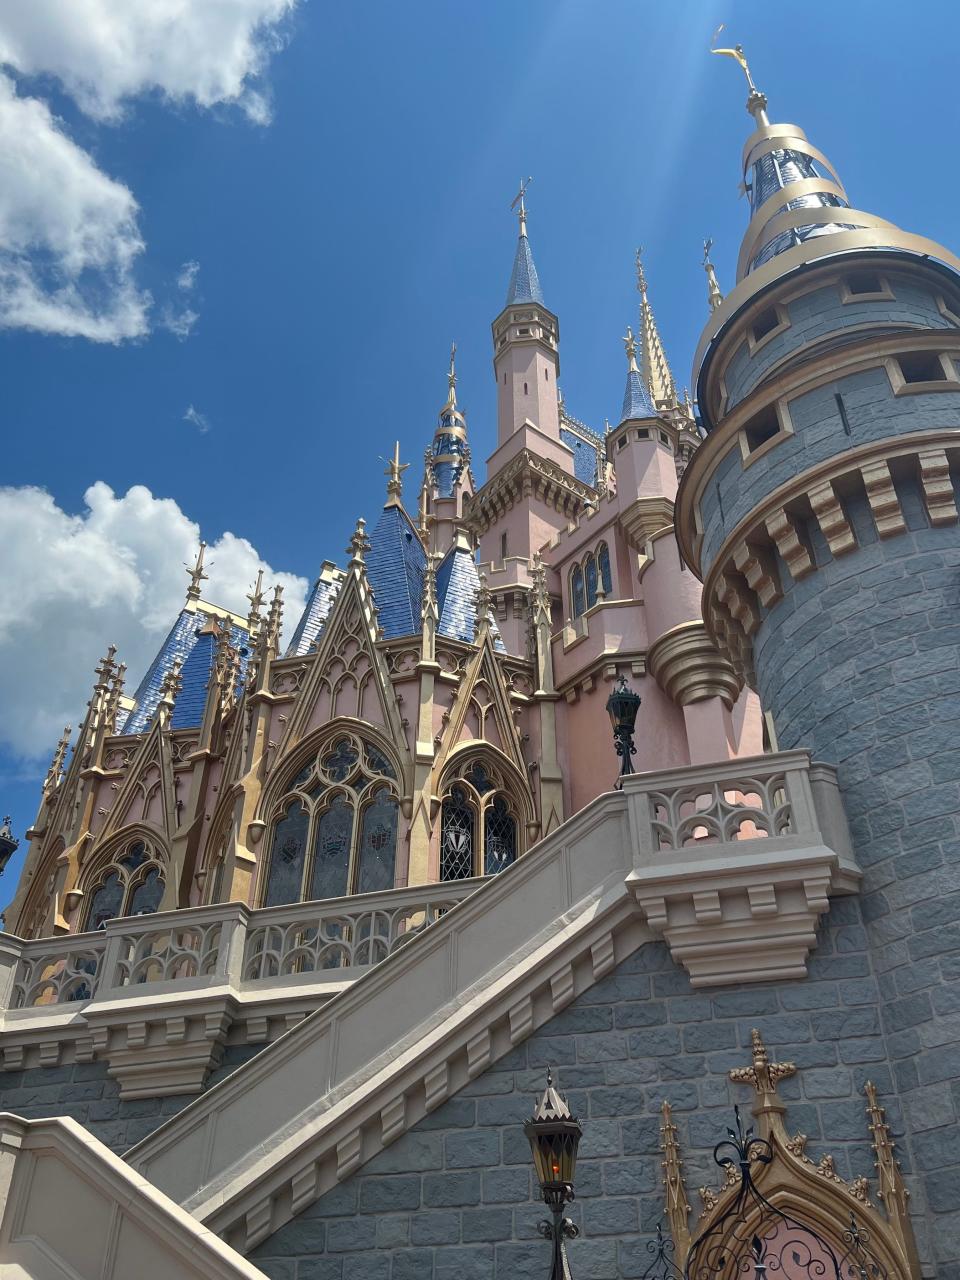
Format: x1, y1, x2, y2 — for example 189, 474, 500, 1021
252, 921, 960, 1280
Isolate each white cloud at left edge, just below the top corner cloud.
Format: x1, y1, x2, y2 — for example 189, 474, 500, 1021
0, 73, 150, 342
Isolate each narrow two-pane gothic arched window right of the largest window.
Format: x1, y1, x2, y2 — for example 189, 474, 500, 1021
440, 759, 520, 881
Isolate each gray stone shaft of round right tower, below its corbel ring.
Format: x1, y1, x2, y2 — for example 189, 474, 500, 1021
754, 484, 960, 1261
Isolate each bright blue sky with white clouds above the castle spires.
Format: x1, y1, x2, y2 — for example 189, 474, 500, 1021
0, 0, 960, 901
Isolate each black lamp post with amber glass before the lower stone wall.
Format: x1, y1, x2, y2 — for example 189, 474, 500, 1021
524, 1070, 582, 1280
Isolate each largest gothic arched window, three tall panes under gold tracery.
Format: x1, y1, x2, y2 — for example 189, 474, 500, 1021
261, 733, 399, 906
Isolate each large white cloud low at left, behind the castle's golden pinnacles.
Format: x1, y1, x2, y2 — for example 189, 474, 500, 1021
0, 481, 307, 758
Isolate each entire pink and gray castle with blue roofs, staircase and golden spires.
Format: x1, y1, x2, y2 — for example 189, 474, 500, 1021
0, 47, 960, 1280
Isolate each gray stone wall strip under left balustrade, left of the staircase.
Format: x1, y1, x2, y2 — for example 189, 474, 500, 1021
0, 1044, 262, 1155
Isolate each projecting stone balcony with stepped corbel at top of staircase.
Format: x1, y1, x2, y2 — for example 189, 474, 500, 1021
625, 751, 860, 987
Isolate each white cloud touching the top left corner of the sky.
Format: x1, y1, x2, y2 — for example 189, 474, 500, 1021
0, 0, 297, 123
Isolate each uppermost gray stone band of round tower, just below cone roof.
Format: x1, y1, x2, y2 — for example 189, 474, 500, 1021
723, 279, 952, 408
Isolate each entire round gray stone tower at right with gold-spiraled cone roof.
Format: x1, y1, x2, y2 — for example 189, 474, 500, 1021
677, 46, 960, 1239
